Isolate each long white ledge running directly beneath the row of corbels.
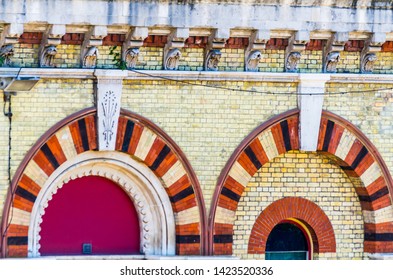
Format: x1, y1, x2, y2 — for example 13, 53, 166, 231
0, 67, 393, 84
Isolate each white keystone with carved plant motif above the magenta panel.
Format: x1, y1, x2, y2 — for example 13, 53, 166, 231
94, 70, 127, 151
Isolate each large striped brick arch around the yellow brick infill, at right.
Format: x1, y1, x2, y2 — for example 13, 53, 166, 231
209, 109, 393, 255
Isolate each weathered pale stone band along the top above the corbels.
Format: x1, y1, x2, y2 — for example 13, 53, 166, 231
0, 0, 393, 33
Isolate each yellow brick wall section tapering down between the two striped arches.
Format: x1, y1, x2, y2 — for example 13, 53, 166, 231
122, 81, 296, 209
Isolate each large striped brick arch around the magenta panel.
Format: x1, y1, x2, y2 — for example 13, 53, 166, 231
1, 108, 207, 257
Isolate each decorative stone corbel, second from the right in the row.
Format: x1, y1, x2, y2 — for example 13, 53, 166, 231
323, 32, 349, 73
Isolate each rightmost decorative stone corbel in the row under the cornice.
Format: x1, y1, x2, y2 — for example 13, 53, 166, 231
360, 33, 386, 74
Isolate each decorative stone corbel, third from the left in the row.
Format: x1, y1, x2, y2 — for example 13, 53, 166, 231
81, 26, 107, 68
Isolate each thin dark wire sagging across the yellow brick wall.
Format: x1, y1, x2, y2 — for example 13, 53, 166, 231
129, 69, 393, 96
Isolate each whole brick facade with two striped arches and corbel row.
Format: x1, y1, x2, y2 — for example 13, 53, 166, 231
0, 0, 393, 259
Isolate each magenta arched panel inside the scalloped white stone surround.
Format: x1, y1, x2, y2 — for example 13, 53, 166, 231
40, 176, 140, 256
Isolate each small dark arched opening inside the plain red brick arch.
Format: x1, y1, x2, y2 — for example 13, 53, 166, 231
265, 220, 312, 260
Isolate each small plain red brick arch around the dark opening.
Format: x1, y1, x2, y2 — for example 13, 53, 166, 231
248, 197, 336, 254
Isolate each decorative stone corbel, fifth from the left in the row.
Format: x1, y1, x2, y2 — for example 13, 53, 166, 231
163, 28, 189, 70
